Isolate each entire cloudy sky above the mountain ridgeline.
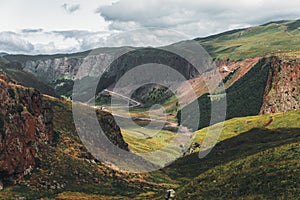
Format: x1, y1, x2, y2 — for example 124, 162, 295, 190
0, 0, 300, 54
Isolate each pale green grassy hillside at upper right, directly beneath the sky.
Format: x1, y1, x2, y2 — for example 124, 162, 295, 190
196, 20, 300, 60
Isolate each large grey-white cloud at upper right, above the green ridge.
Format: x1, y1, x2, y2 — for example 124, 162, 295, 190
97, 0, 300, 37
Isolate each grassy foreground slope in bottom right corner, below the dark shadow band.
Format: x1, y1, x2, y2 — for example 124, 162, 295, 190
177, 140, 300, 199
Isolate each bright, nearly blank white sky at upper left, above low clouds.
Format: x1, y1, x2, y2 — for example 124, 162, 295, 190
0, 0, 115, 32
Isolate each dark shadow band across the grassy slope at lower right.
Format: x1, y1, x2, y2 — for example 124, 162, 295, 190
162, 128, 300, 180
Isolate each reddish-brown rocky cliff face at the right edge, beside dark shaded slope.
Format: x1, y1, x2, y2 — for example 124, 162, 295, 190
260, 57, 300, 114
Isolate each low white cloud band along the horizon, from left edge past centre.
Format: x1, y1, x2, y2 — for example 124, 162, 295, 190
0, 28, 189, 54
